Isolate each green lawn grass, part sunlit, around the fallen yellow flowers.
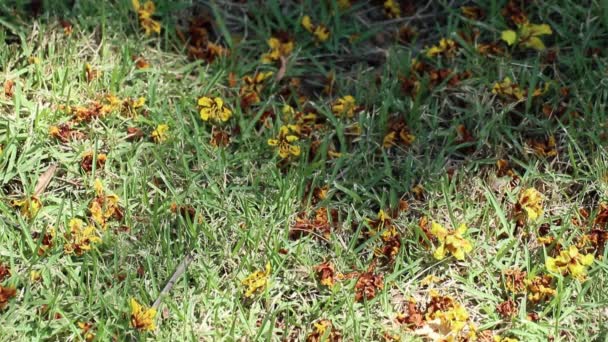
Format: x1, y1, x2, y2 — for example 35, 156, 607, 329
0, 1, 608, 341
